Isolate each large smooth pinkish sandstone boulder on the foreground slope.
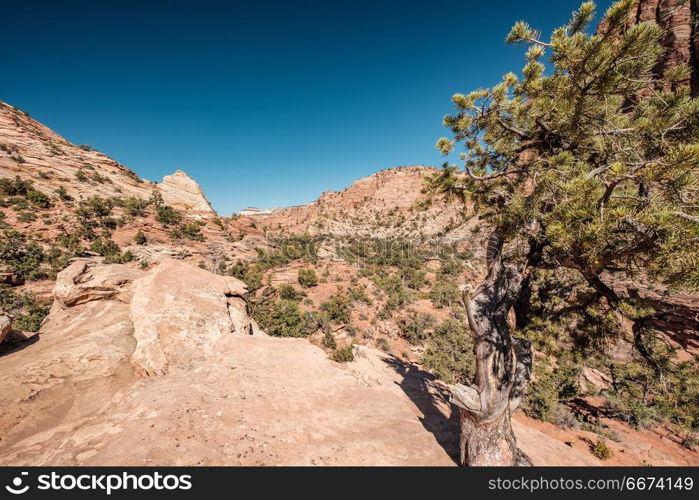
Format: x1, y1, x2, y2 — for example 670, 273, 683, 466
130, 260, 251, 376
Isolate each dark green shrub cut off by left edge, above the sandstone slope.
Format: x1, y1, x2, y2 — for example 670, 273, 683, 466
0, 230, 47, 281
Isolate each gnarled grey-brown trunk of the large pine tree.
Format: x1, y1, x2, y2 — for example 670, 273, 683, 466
452, 234, 532, 466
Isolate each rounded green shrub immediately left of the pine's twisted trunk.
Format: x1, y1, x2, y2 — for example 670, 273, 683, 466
422, 318, 476, 384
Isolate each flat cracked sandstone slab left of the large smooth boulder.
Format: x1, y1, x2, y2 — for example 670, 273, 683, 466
53, 259, 143, 307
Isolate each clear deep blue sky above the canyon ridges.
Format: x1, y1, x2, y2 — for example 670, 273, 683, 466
0, 0, 610, 215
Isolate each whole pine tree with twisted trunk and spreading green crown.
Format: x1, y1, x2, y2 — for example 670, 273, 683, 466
430, 0, 699, 465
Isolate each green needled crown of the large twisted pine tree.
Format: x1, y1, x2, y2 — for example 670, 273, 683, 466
430, 0, 699, 289
